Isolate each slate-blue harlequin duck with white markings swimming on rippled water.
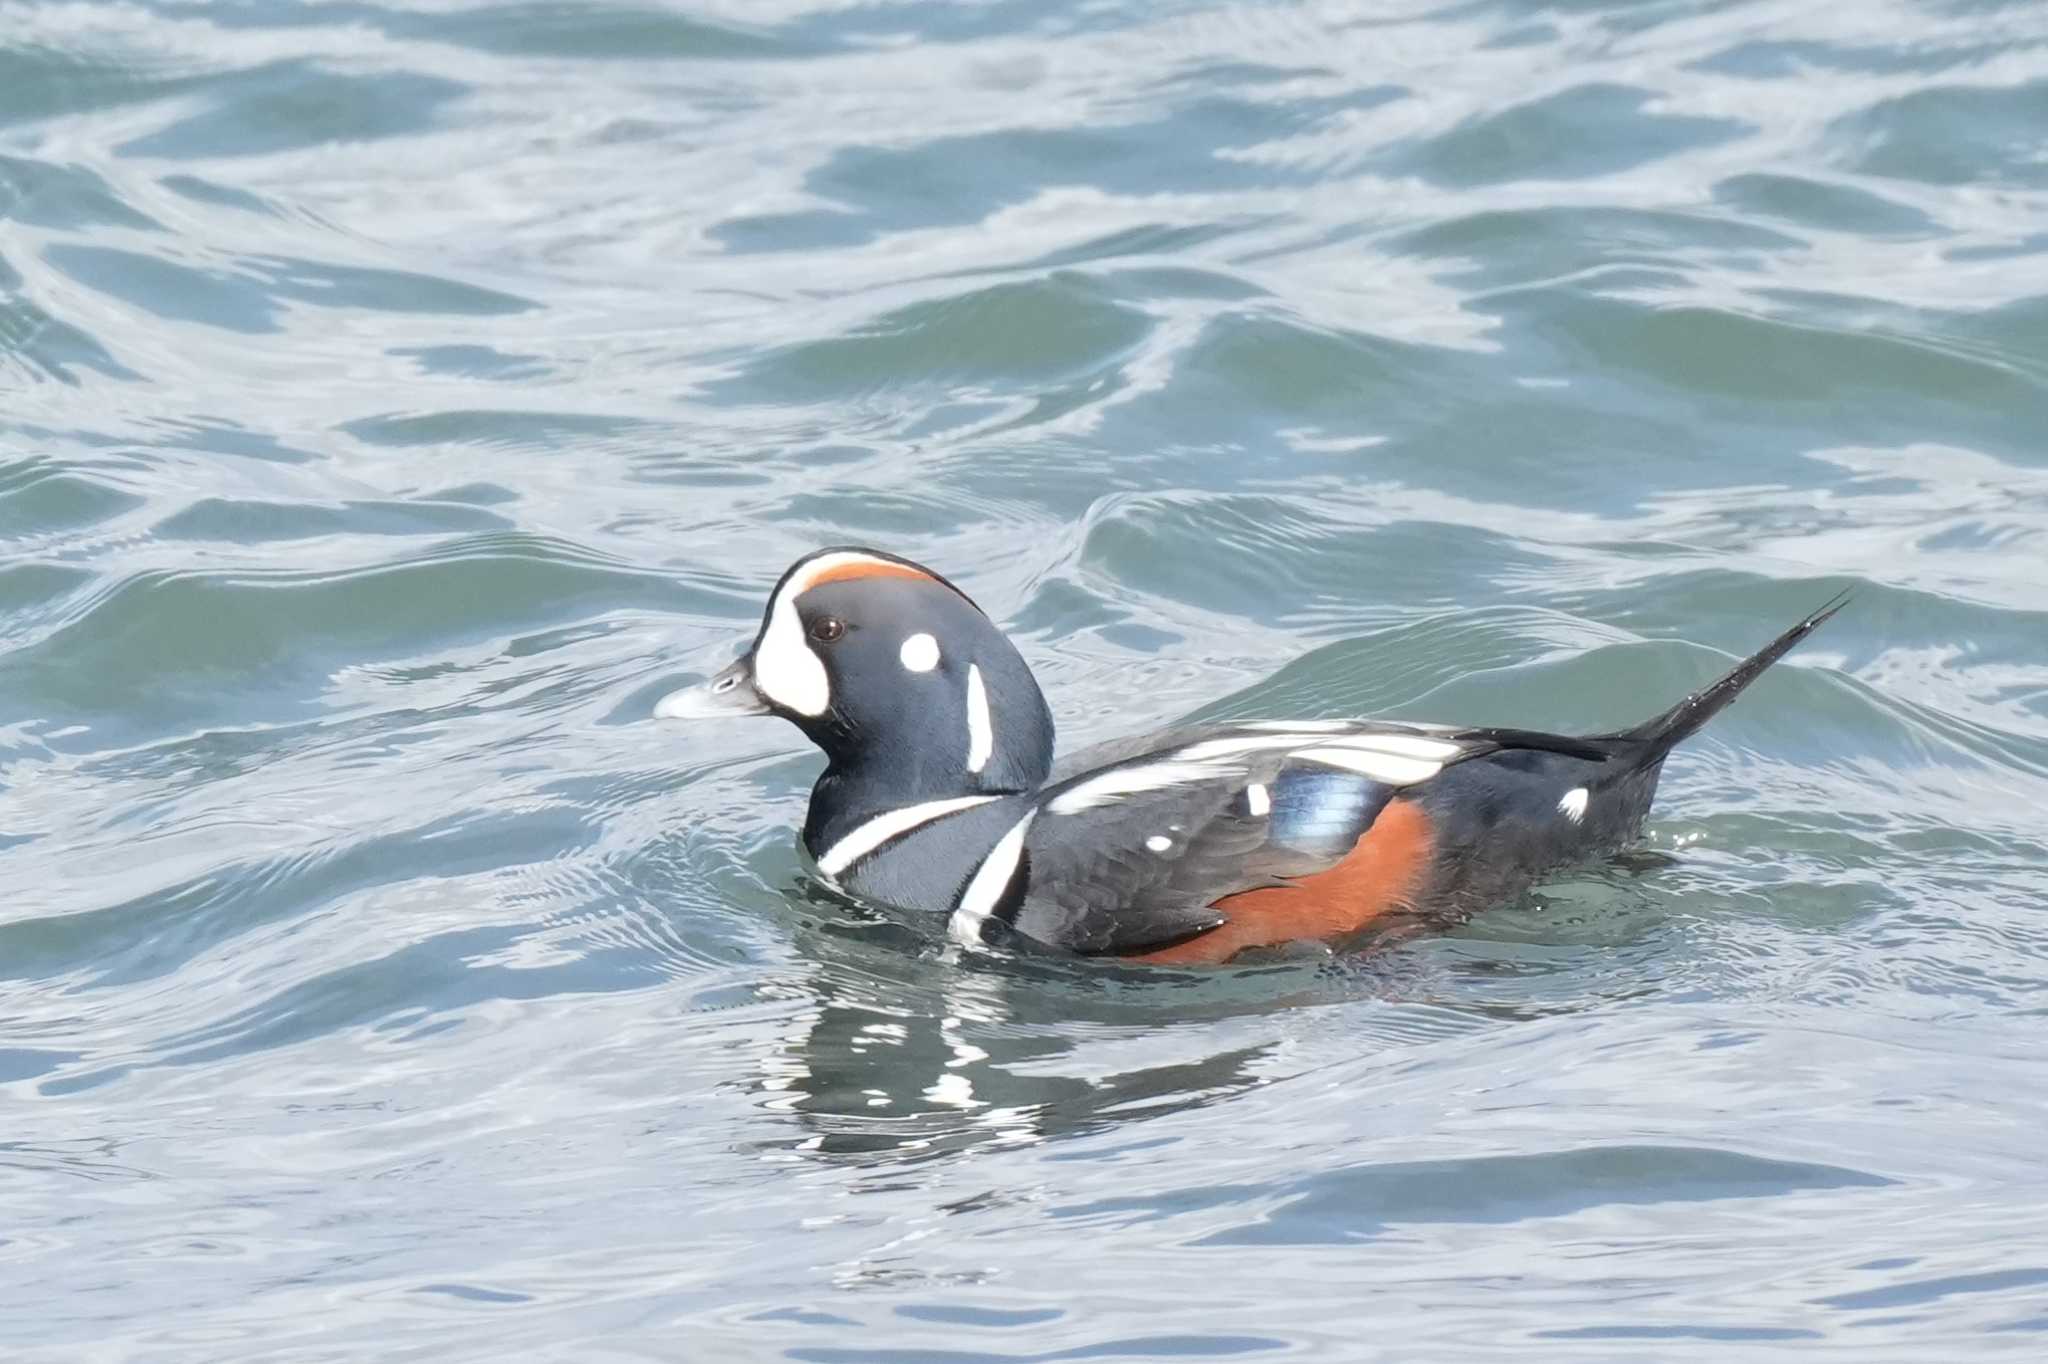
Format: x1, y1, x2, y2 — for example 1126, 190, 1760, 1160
653, 547, 1845, 963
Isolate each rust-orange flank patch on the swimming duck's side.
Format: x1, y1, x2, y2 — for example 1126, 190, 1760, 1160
1130, 801, 1436, 965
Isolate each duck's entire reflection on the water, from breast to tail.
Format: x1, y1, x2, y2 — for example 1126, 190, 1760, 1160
752, 854, 1671, 1165
